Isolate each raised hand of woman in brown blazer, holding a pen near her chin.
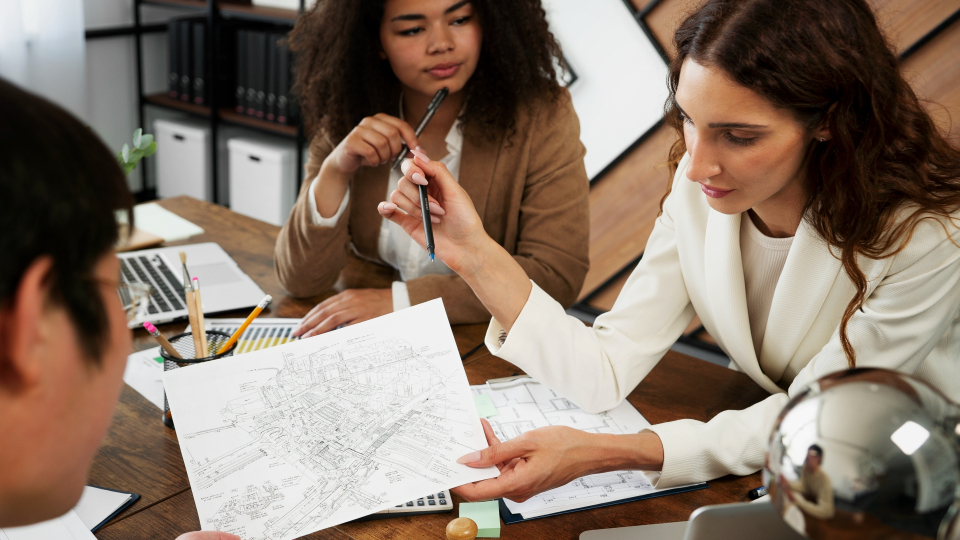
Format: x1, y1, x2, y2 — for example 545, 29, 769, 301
324, 113, 419, 175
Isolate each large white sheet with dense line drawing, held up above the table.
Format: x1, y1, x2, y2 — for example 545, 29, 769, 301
164, 300, 498, 540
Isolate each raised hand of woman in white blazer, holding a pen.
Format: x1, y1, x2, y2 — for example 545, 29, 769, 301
378, 150, 496, 277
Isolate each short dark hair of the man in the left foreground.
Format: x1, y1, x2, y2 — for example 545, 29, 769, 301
0, 80, 133, 363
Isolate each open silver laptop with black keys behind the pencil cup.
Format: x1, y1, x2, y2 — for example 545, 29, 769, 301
117, 242, 265, 328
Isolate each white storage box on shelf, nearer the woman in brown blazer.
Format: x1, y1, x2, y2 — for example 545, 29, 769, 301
227, 137, 297, 226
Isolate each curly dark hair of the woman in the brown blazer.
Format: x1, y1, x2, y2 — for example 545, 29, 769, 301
290, 0, 565, 142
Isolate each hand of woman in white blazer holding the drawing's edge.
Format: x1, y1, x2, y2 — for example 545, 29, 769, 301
452, 419, 597, 502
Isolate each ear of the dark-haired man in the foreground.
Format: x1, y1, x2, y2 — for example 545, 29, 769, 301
0, 256, 53, 391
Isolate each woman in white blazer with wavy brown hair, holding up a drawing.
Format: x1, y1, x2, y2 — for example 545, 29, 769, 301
380, 0, 960, 500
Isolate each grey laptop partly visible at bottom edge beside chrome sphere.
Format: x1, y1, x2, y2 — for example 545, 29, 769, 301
580, 502, 804, 540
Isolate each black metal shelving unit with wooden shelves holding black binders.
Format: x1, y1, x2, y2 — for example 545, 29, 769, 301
133, 0, 305, 202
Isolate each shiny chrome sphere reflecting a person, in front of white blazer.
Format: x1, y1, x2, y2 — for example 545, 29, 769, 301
764, 369, 960, 540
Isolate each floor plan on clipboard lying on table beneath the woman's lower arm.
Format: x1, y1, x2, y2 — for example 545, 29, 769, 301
470, 377, 704, 519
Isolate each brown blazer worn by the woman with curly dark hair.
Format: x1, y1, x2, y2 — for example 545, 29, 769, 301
274, 91, 589, 324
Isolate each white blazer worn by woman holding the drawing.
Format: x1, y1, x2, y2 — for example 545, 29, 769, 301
486, 156, 960, 487
